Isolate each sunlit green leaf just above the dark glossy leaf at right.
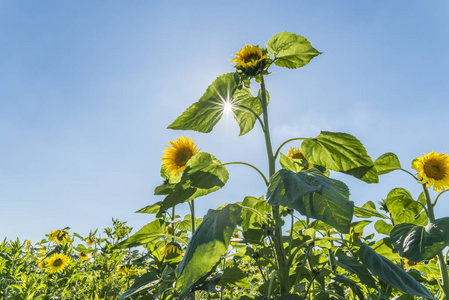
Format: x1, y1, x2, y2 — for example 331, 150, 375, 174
385, 188, 428, 225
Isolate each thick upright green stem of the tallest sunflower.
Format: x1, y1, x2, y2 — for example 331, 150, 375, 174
260, 76, 290, 294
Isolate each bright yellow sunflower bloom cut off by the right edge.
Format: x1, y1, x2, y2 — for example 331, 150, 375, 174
412, 151, 449, 192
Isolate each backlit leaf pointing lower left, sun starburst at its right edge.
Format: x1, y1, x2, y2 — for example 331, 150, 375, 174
168, 73, 240, 133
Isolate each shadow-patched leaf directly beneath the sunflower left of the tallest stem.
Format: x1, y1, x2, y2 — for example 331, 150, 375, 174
161, 152, 229, 211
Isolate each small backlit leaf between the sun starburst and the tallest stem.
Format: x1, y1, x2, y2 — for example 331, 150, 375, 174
232, 88, 262, 135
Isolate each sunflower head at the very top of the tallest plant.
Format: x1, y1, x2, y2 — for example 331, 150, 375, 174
232, 44, 270, 76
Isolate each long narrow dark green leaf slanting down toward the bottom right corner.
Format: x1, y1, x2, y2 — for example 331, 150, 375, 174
359, 245, 435, 299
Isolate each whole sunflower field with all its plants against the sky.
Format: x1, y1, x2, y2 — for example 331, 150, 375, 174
0, 32, 449, 300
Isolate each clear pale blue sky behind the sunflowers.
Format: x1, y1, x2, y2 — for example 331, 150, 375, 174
0, 0, 449, 242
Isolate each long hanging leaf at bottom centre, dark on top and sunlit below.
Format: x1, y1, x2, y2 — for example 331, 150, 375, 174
176, 204, 242, 297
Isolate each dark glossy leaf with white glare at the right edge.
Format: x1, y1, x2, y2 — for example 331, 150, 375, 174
390, 217, 449, 262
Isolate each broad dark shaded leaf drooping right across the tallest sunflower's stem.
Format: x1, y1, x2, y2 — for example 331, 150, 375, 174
267, 168, 354, 233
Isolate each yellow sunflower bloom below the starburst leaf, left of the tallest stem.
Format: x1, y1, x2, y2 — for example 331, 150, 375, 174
162, 136, 199, 177
